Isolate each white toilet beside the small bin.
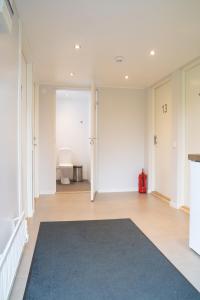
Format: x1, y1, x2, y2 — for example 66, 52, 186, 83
57, 148, 73, 184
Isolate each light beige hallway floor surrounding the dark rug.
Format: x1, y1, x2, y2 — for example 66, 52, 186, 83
10, 192, 200, 300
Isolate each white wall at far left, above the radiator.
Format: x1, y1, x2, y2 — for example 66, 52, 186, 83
0, 5, 21, 217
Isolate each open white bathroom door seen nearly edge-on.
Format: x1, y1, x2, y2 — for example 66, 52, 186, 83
90, 84, 97, 201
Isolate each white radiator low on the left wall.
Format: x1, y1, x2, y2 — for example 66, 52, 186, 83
0, 216, 28, 300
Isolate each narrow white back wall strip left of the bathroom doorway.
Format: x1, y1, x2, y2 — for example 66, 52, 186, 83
39, 86, 56, 194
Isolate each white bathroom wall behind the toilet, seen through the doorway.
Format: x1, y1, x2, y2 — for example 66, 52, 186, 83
56, 90, 91, 179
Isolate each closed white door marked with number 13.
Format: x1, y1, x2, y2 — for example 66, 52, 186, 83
154, 81, 172, 199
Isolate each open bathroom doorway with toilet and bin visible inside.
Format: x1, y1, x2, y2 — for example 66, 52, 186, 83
56, 89, 91, 193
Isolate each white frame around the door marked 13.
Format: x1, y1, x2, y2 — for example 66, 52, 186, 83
148, 74, 185, 208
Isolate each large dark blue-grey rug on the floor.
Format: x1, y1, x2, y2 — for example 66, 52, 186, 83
24, 219, 200, 300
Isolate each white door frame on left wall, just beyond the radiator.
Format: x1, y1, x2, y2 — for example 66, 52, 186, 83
18, 52, 34, 218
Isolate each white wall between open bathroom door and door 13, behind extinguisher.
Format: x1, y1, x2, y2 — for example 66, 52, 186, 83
98, 88, 146, 192
